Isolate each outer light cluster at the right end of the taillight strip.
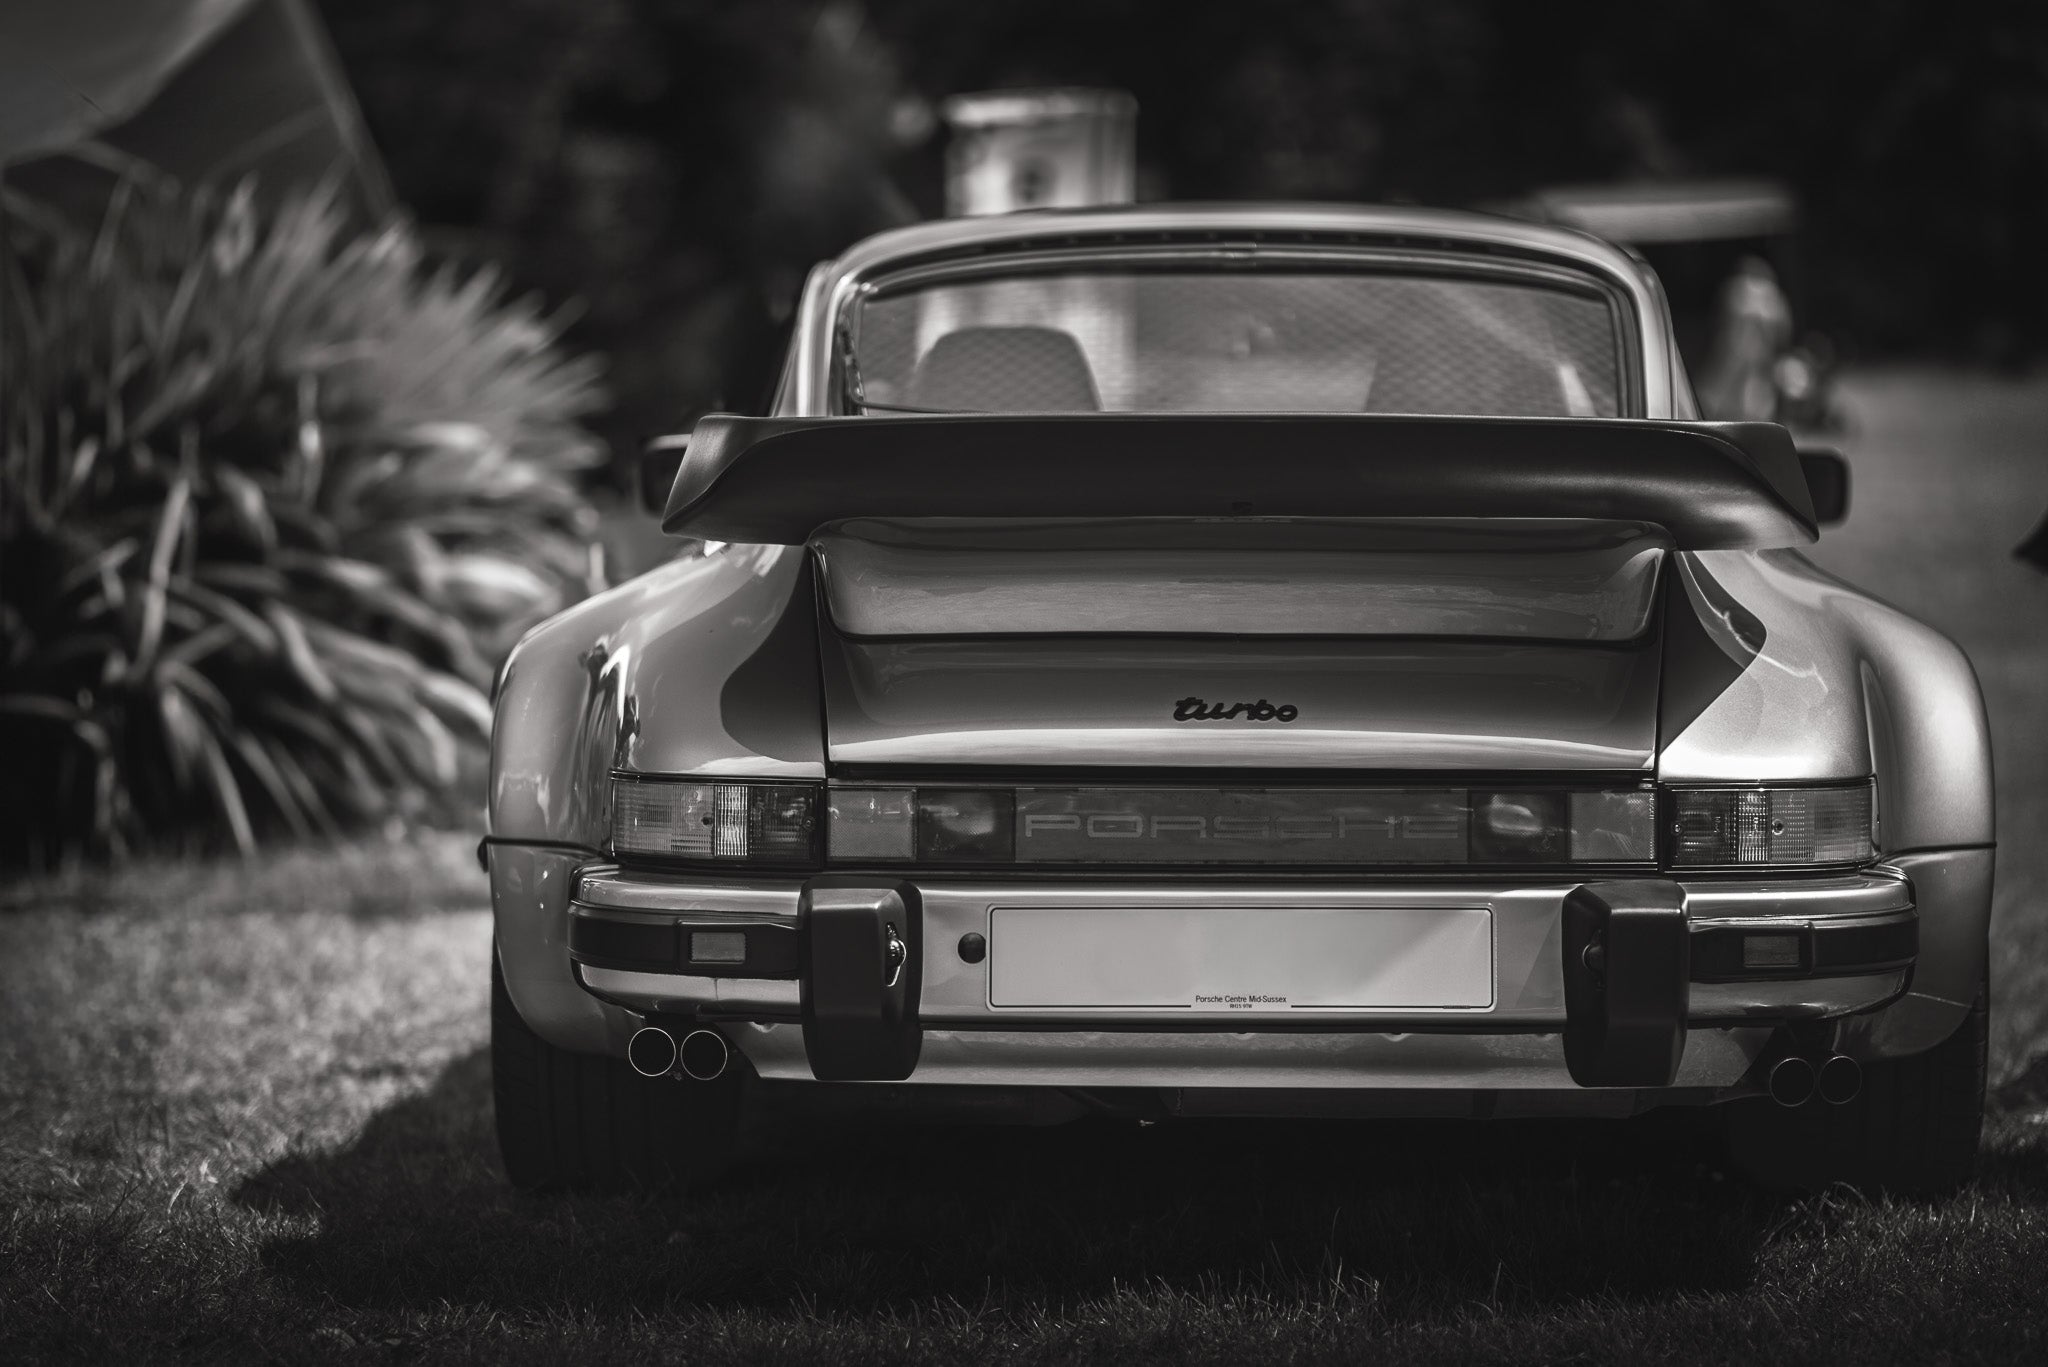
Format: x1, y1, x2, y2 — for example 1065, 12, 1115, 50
1665, 779, 1872, 869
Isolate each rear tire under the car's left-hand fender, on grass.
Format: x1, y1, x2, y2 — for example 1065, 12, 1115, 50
492, 953, 748, 1191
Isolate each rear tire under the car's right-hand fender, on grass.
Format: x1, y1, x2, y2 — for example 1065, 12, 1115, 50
1722, 990, 1989, 1197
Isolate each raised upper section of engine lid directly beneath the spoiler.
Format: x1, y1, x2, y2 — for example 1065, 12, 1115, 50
811, 519, 1671, 641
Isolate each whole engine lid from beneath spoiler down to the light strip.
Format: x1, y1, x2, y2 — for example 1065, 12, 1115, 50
813, 519, 1669, 771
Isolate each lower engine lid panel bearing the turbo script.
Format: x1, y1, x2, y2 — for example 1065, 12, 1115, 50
825, 635, 1659, 771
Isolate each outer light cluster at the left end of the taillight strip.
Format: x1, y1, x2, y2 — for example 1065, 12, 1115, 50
612, 775, 821, 865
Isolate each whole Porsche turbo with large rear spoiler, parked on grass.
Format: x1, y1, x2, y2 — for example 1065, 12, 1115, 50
485, 205, 1993, 1191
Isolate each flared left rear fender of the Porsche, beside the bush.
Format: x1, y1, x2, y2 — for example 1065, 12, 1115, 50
487, 545, 825, 1053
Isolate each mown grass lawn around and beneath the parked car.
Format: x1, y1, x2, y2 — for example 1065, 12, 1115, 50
0, 373, 2048, 1363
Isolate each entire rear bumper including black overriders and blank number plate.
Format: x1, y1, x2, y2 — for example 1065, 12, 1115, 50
565, 863, 1921, 1090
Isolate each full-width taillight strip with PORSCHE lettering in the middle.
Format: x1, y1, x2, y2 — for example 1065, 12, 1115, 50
610, 775, 1874, 869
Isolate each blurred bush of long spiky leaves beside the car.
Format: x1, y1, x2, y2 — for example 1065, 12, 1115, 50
0, 182, 602, 863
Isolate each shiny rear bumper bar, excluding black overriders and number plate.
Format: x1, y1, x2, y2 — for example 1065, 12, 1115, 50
548, 865, 1919, 1090
